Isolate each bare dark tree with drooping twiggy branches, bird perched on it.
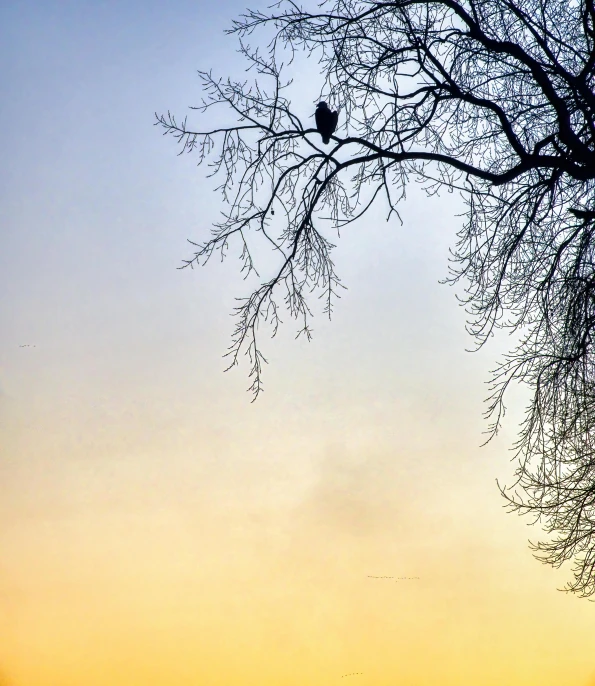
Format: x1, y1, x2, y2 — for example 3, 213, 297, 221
156, 0, 595, 596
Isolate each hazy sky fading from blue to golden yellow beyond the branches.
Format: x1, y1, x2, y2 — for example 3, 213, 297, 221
0, 0, 595, 686
